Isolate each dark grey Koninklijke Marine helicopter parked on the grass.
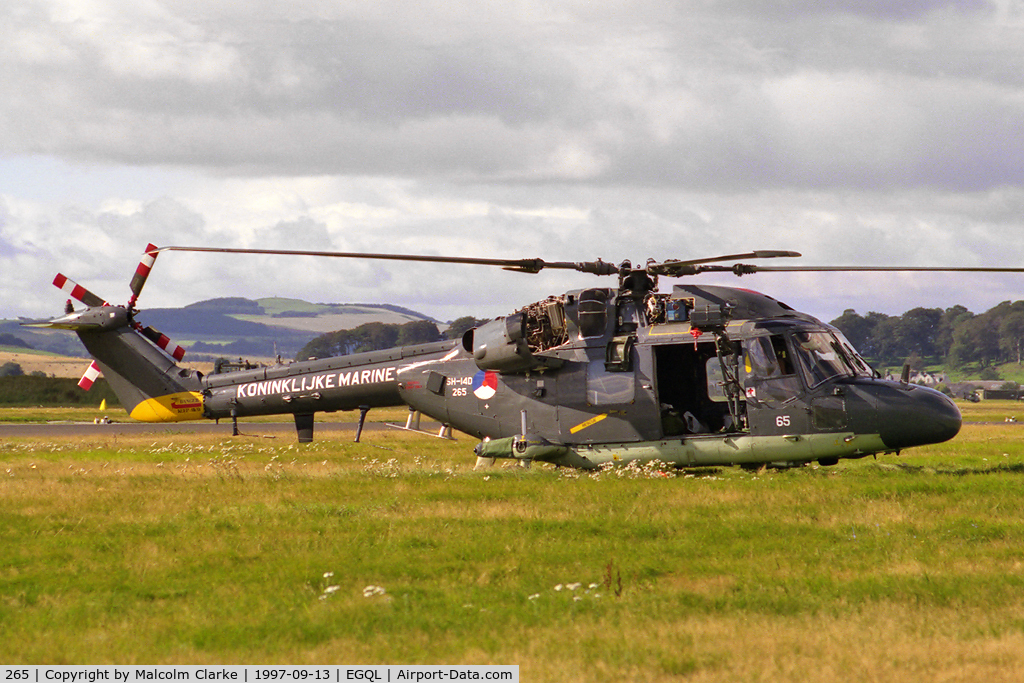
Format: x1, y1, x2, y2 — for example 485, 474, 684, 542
28, 245, 1024, 469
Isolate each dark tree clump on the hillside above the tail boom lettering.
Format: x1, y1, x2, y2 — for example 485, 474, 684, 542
295, 316, 481, 360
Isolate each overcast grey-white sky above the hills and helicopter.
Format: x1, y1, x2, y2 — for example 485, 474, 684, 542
0, 0, 1024, 322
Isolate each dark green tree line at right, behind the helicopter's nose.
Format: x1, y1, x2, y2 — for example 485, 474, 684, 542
831, 301, 1024, 369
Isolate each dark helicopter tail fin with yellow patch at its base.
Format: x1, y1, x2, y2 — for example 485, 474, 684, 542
26, 306, 203, 422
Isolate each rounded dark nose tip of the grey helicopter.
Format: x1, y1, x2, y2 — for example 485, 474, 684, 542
878, 385, 963, 451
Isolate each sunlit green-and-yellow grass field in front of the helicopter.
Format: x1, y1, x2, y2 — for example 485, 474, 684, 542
0, 404, 1024, 682
